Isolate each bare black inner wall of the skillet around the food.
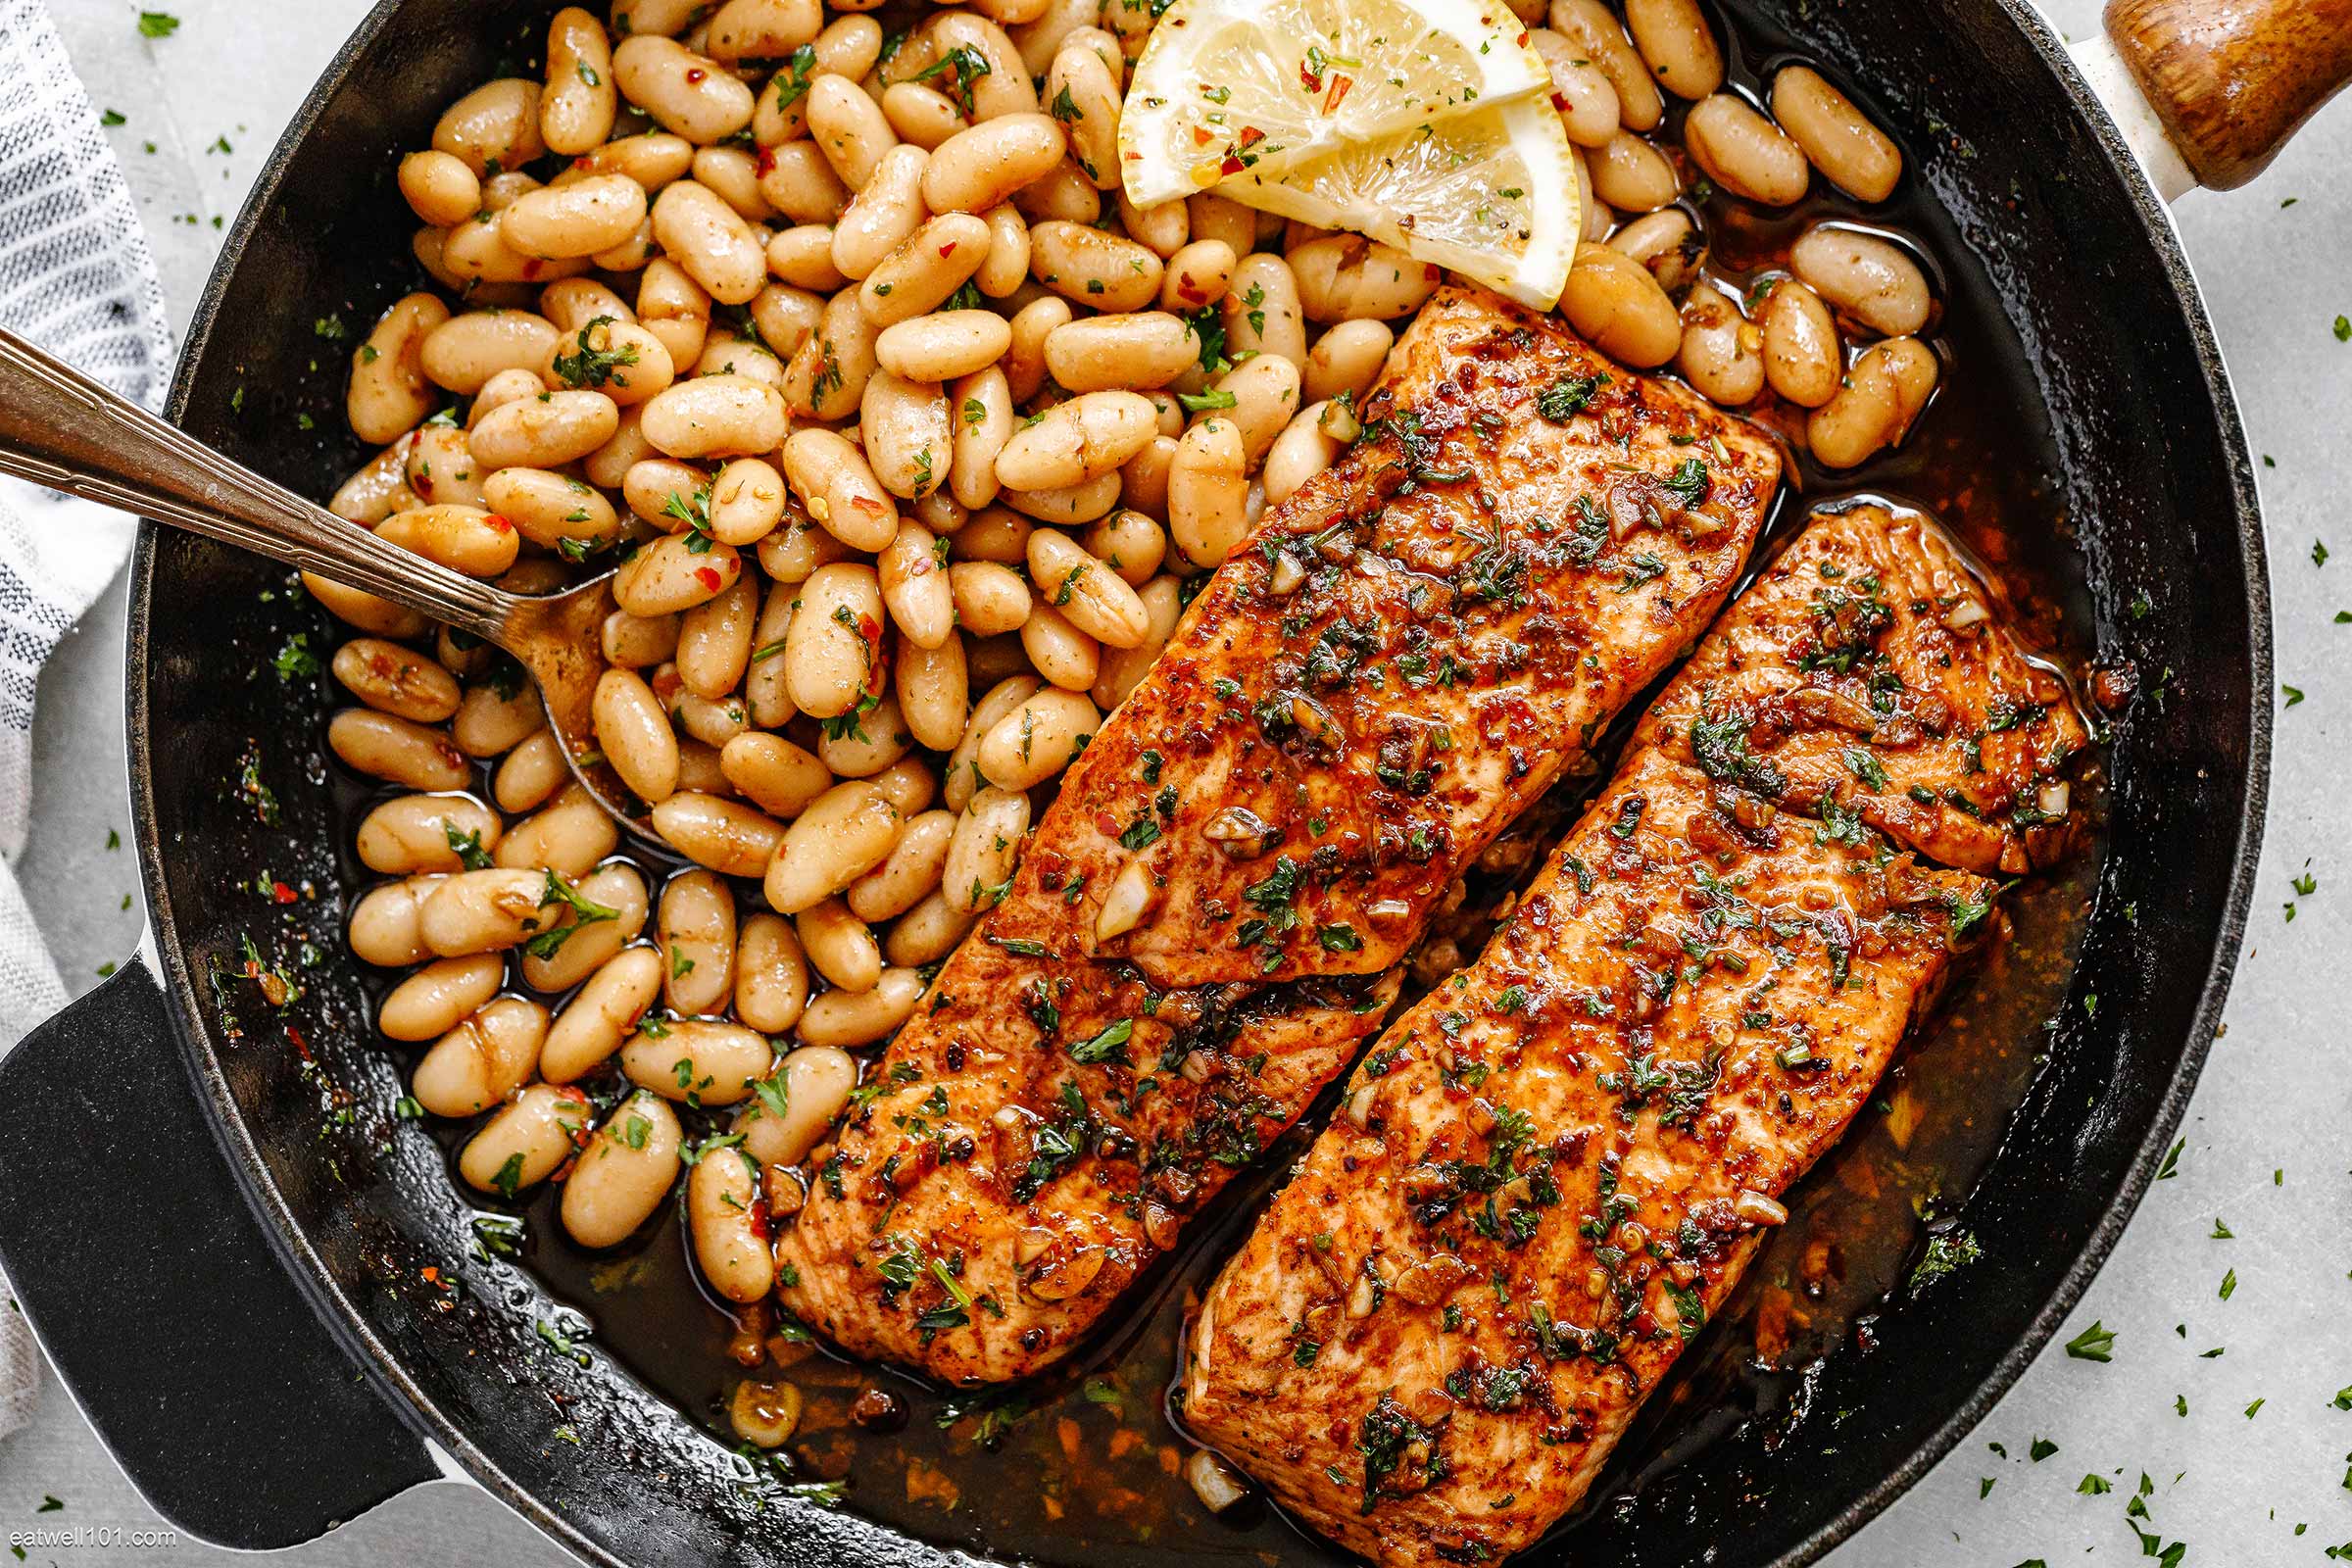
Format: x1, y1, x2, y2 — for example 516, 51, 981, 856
129, 0, 2270, 1568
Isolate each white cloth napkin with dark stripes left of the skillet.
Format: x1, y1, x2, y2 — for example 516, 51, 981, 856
0, 0, 174, 1437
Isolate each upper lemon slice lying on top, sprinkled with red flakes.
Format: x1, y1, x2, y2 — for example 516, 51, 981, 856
1119, 0, 1550, 207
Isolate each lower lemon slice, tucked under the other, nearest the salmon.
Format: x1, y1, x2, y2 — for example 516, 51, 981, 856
1218, 99, 1583, 311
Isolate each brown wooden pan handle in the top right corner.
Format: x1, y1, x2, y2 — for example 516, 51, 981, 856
2107, 0, 2352, 190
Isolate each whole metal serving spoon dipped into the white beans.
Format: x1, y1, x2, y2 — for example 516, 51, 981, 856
0, 326, 675, 854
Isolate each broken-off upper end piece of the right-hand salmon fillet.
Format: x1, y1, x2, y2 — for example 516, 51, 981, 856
1635, 506, 2088, 874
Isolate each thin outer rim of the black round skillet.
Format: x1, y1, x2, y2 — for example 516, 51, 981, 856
124, 0, 2275, 1568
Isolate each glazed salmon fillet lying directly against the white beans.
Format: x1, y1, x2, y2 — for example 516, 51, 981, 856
776, 289, 1778, 1385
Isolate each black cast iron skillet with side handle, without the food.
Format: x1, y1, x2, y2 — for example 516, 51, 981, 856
0, 0, 2295, 1568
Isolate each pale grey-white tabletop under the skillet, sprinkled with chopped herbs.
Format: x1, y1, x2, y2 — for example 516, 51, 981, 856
0, 0, 2352, 1568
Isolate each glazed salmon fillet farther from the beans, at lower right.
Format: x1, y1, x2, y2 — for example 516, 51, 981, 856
1181, 511, 2056, 1563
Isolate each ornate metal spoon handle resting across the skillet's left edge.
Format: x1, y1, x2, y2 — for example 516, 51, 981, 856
0, 326, 515, 642
